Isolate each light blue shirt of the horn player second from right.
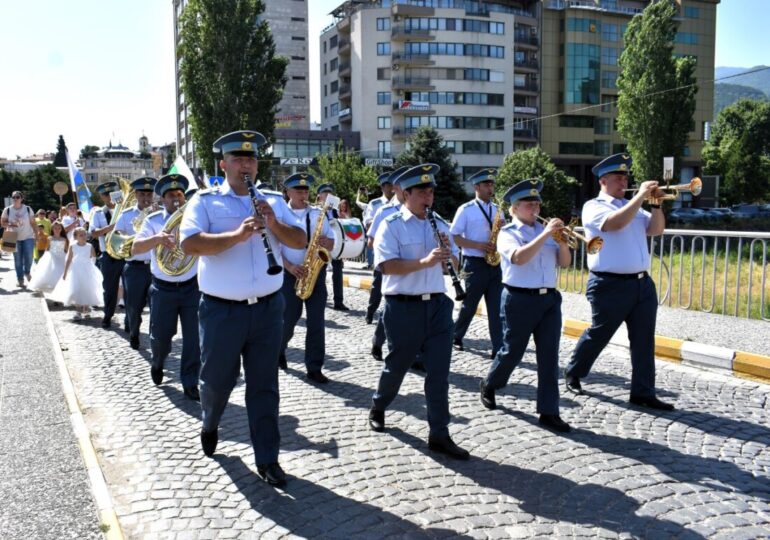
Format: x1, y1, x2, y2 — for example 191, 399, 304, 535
497, 218, 559, 289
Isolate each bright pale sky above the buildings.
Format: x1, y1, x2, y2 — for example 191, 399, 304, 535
0, 0, 770, 159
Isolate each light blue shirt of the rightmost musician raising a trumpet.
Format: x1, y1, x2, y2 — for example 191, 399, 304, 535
582, 192, 652, 274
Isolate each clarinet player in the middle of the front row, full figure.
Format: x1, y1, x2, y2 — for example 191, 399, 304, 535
369, 164, 470, 459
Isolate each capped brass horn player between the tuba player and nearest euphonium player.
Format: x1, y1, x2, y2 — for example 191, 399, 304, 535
114, 176, 157, 349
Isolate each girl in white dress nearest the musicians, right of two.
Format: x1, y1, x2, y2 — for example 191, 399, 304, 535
50, 227, 104, 320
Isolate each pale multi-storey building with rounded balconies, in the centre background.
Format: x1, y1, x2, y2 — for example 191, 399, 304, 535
320, 0, 539, 184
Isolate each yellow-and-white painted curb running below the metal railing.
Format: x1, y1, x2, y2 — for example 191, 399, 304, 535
342, 276, 770, 383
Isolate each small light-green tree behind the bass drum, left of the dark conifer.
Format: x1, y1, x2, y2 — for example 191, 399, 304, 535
312, 141, 378, 221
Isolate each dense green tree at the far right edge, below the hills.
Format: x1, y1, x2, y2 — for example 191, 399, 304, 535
703, 99, 770, 204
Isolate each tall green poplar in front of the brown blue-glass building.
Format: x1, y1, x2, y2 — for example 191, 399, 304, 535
617, 1, 698, 180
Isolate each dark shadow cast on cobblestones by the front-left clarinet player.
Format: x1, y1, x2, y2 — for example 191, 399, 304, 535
214, 456, 469, 539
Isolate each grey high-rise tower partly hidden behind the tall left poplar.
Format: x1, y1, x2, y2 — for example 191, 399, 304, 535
172, 0, 310, 167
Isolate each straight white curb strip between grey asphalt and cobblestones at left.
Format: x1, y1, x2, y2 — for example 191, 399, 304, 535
40, 298, 124, 540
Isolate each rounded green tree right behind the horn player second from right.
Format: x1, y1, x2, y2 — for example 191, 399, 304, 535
495, 147, 579, 219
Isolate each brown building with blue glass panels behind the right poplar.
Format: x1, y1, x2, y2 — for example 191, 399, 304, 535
540, 0, 719, 204
